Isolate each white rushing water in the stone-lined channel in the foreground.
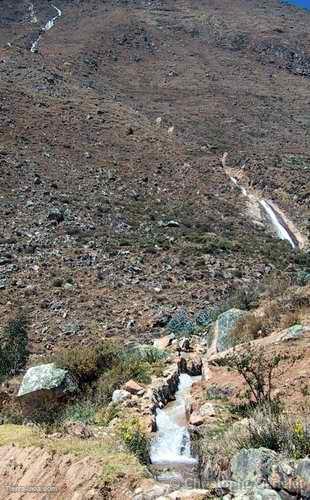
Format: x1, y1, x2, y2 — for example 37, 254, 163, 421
150, 373, 197, 464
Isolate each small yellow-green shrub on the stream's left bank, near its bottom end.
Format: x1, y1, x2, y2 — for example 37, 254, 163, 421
119, 417, 150, 464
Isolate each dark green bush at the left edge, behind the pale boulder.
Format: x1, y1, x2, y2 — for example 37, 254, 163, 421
0, 317, 29, 381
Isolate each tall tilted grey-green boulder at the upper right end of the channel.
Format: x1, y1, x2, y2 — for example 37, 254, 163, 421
208, 309, 247, 353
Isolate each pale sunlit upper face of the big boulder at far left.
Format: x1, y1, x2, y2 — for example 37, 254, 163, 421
17, 363, 78, 397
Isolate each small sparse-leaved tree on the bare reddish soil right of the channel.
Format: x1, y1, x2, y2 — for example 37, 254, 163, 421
217, 345, 287, 404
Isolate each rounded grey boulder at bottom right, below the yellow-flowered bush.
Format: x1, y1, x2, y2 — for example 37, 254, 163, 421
231, 448, 277, 484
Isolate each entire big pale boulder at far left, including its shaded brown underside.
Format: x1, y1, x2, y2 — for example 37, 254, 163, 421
17, 363, 78, 414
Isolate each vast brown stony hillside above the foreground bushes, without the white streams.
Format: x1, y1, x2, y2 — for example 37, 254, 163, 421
0, 0, 310, 355
